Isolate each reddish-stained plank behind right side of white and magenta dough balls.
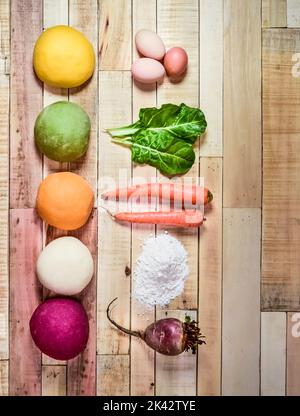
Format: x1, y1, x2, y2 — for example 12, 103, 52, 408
47, 209, 97, 396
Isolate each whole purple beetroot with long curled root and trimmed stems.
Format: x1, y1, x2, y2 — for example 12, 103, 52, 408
106, 298, 205, 355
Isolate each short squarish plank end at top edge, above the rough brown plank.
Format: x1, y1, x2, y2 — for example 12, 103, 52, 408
262, 0, 288, 28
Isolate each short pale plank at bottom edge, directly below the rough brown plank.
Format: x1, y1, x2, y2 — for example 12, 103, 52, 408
261, 312, 286, 396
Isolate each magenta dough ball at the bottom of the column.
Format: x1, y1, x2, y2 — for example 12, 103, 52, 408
29, 298, 89, 360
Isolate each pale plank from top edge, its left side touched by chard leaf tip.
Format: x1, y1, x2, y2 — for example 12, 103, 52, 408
199, 0, 223, 156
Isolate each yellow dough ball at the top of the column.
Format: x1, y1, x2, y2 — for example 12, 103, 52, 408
33, 26, 95, 88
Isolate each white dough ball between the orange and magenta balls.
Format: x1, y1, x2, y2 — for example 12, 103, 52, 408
36, 237, 94, 296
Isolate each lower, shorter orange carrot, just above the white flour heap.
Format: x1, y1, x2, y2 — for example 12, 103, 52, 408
111, 210, 204, 227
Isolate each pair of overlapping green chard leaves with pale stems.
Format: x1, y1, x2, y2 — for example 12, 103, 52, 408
107, 104, 207, 176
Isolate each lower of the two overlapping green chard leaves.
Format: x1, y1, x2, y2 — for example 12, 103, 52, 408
119, 132, 195, 176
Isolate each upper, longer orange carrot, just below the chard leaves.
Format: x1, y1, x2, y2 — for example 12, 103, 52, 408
101, 183, 213, 205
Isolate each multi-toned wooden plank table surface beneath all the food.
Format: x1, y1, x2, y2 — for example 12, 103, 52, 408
0, 0, 300, 396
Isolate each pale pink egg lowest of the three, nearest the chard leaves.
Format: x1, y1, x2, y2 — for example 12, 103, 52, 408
131, 58, 165, 84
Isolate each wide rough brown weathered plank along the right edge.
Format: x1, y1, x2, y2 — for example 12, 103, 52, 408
262, 29, 300, 311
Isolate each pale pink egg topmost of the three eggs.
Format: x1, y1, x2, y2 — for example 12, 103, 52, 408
135, 30, 166, 61
